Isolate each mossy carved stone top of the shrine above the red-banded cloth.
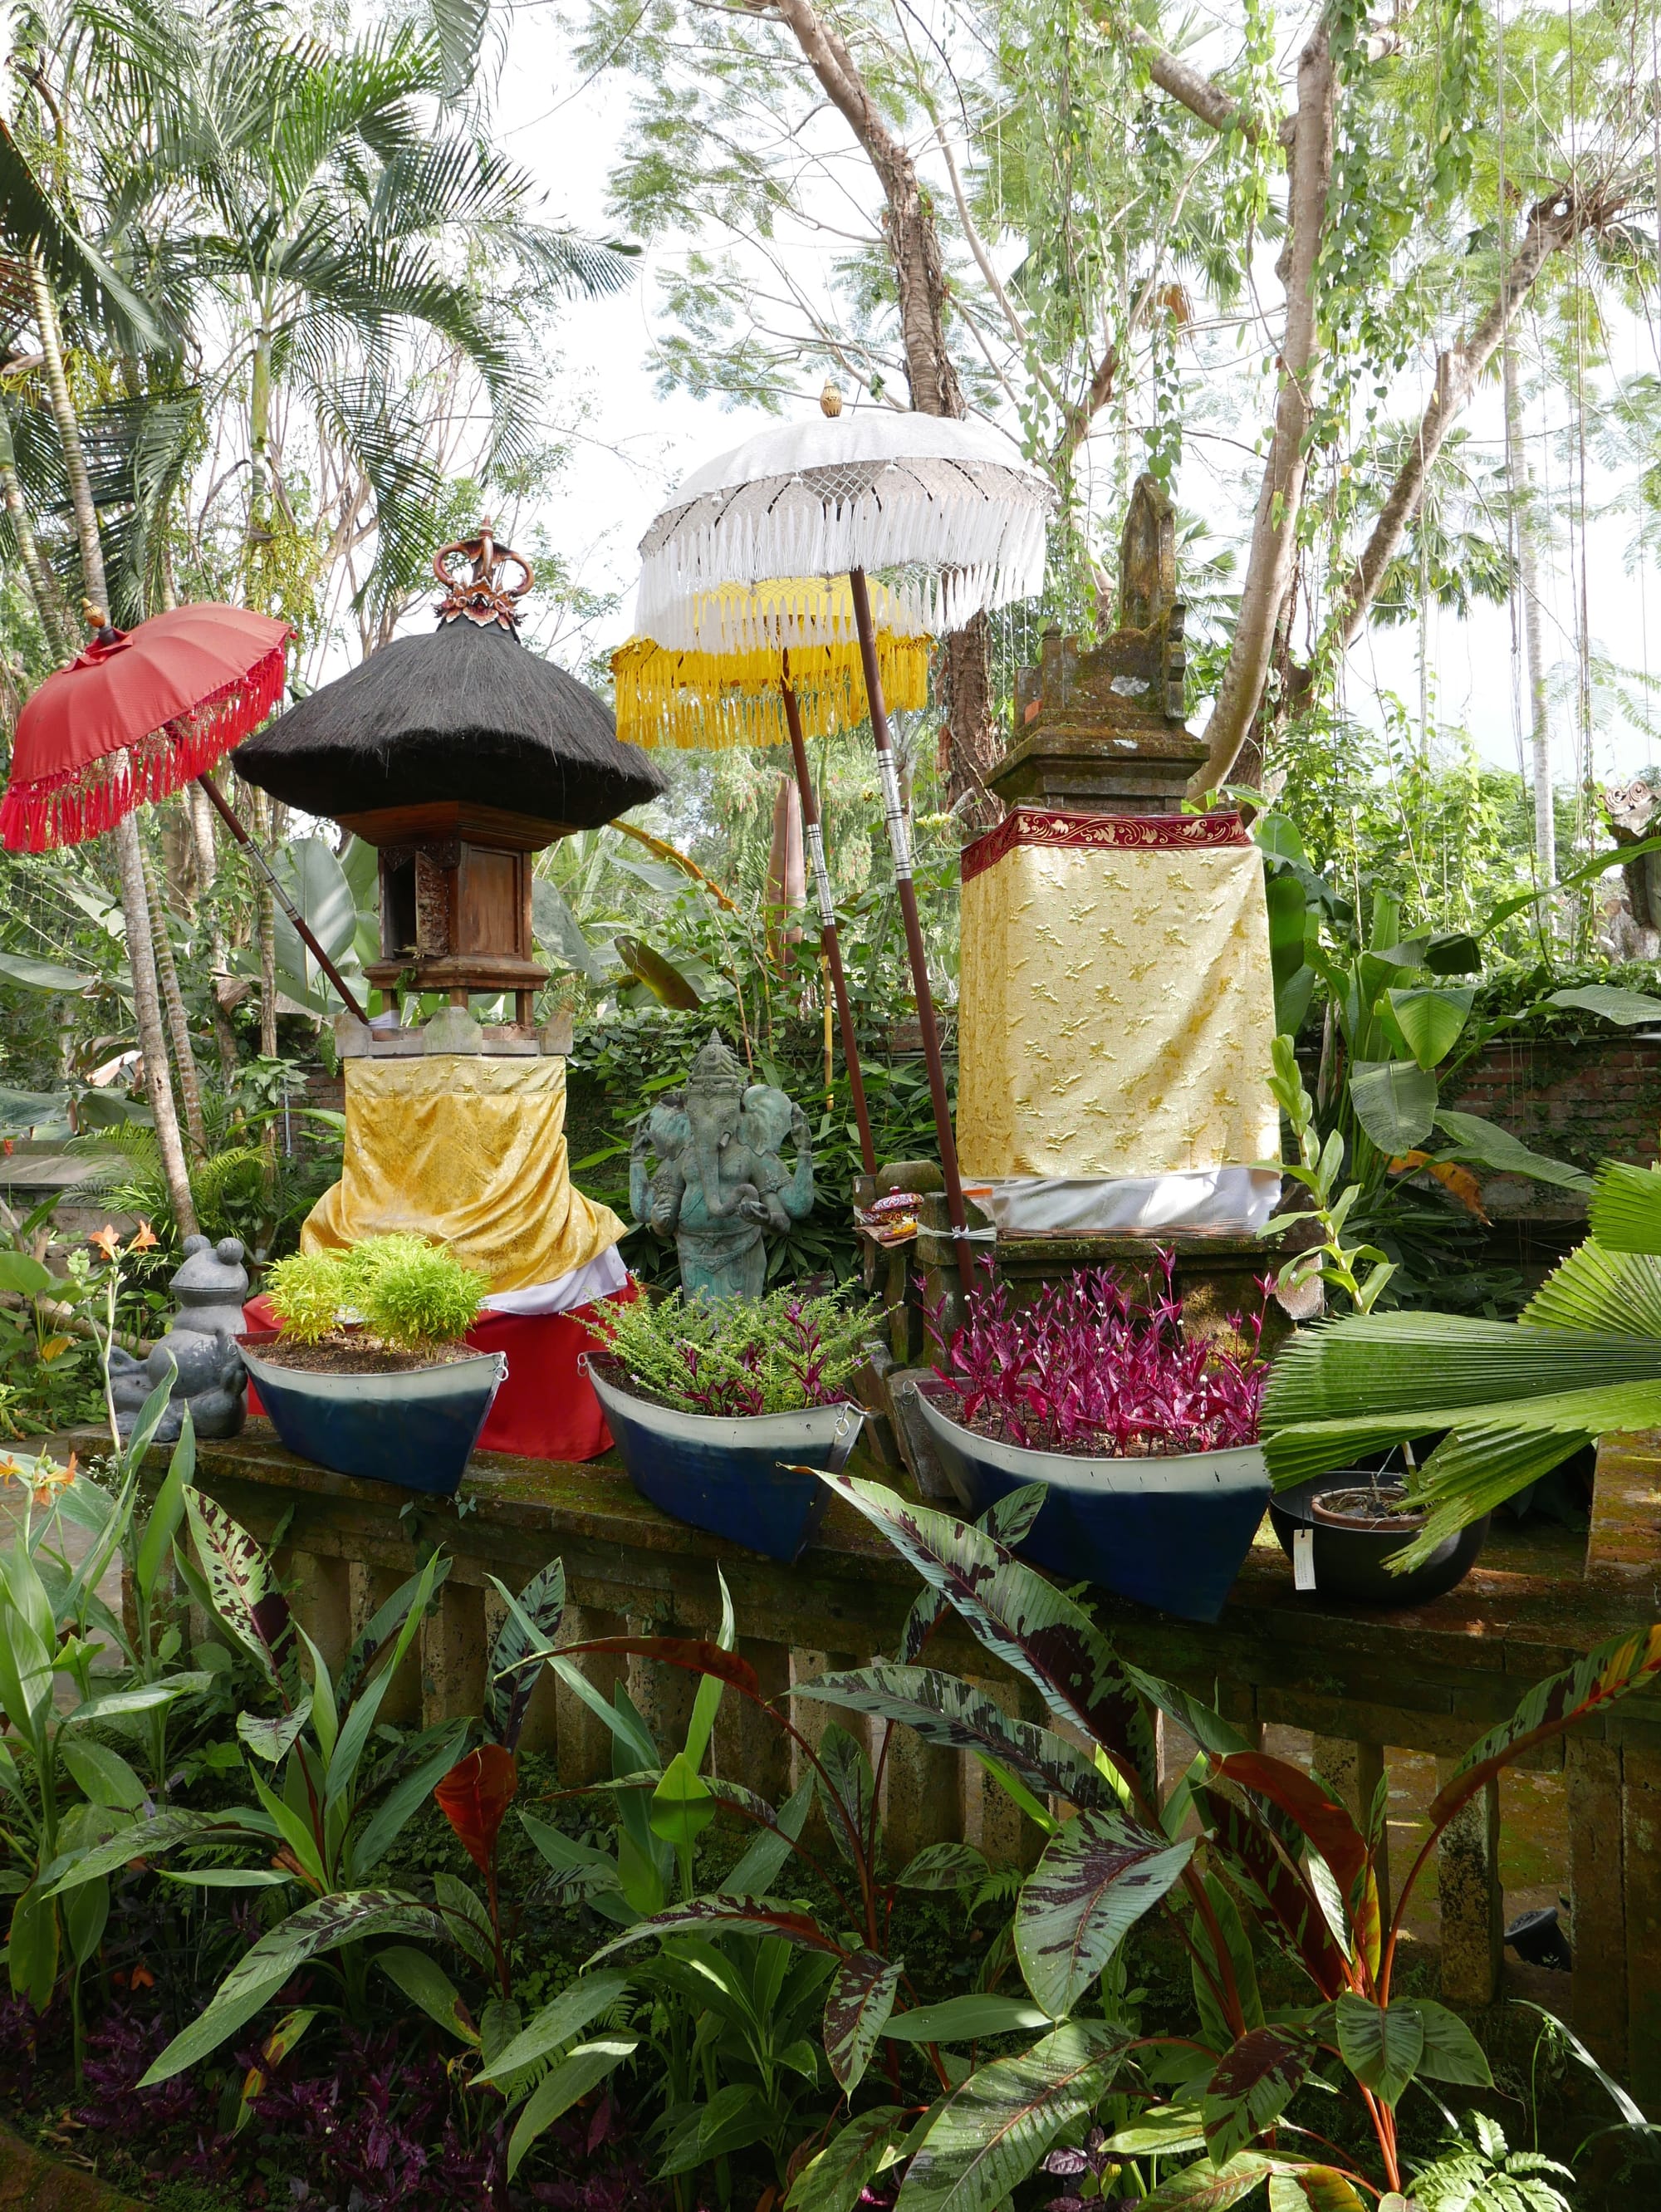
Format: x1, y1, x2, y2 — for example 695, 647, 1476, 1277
987, 473, 1205, 814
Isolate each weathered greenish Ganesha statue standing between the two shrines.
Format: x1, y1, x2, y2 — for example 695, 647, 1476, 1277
628, 1035, 814, 1301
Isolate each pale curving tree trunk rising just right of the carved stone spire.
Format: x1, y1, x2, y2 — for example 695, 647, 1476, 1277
1188, 22, 1336, 797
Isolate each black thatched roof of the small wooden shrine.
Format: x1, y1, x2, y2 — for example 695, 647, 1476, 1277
234, 620, 664, 830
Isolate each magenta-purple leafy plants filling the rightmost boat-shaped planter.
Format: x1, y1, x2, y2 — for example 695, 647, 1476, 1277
931, 1252, 1267, 1458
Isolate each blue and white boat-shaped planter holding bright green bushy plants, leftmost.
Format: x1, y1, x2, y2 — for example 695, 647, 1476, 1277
237, 1329, 507, 1498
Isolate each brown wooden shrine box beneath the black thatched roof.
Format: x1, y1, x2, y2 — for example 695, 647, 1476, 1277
338, 798, 566, 1028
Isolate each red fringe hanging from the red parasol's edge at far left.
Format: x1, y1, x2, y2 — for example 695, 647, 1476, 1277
0, 644, 287, 851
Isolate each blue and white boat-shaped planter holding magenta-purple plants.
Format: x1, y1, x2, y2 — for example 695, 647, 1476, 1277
918, 1389, 1270, 1621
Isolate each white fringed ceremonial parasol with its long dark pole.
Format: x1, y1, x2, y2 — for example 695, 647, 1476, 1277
635, 398, 1053, 1290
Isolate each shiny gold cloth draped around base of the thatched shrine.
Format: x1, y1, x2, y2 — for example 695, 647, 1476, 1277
301, 1053, 626, 1292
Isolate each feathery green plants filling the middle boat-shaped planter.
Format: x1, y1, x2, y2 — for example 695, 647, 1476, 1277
593, 1290, 871, 1415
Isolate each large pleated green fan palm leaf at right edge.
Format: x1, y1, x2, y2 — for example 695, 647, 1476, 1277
1258, 1161, 1661, 1571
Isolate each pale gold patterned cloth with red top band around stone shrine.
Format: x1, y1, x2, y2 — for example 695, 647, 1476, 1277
958, 807, 1281, 1179
